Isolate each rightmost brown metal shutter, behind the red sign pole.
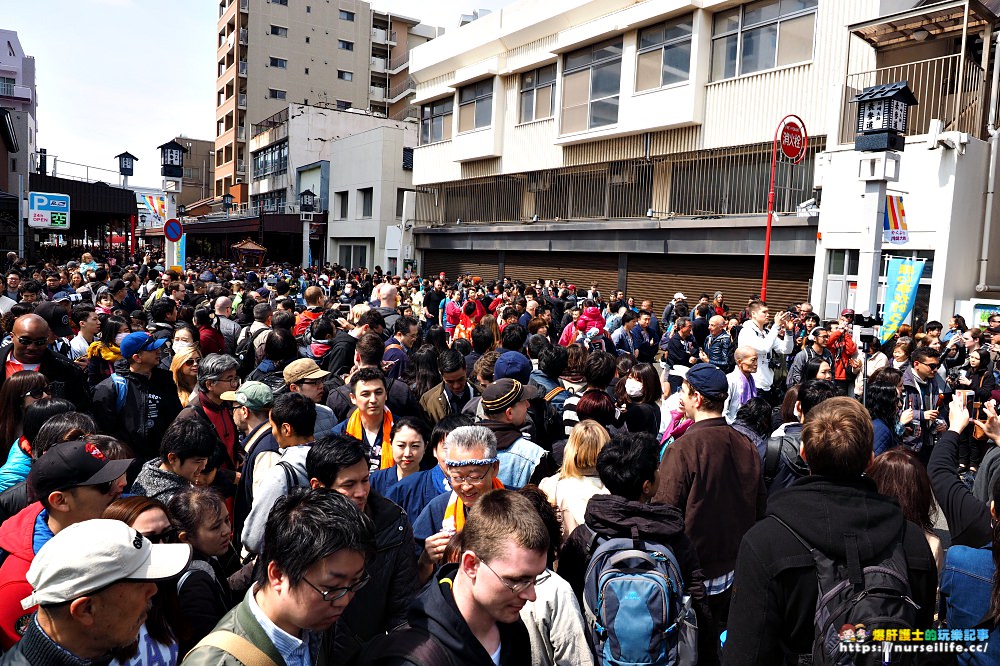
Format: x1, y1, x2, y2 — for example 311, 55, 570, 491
625, 254, 813, 313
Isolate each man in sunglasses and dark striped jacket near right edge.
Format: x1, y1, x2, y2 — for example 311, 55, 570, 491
903, 347, 948, 464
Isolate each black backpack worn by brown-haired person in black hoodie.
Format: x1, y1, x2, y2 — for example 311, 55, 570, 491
771, 514, 920, 666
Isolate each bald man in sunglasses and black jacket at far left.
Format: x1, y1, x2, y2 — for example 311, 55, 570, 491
0, 314, 90, 411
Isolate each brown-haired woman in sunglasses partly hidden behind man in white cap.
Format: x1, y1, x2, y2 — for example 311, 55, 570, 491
102, 496, 191, 666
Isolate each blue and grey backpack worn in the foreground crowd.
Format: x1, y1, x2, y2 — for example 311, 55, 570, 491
583, 526, 698, 666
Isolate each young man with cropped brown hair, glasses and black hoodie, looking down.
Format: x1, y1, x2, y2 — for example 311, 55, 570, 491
369, 490, 544, 666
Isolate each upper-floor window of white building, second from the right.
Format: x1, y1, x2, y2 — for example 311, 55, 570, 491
635, 14, 692, 90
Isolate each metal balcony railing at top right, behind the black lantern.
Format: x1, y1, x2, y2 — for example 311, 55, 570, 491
840, 55, 986, 143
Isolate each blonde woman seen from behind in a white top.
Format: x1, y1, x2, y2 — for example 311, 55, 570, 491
539, 419, 611, 541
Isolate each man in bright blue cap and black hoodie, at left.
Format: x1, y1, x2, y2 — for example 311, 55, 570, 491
93, 331, 181, 463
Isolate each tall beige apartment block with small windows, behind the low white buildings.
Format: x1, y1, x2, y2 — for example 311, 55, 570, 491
213, 0, 440, 197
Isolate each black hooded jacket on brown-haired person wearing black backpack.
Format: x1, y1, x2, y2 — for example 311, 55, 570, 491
723, 476, 937, 666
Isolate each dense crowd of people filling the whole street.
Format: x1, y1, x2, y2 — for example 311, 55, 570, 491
0, 246, 1000, 666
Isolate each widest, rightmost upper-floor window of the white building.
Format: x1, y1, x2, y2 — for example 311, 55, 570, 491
712, 0, 818, 81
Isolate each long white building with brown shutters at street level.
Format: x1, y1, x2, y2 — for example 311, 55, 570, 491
404, 0, 996, 322
